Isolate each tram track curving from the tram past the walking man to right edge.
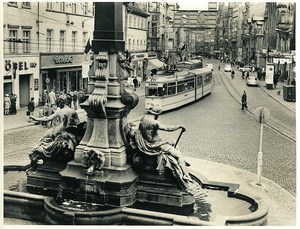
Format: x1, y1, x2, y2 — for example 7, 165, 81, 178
214, 65, 296, 143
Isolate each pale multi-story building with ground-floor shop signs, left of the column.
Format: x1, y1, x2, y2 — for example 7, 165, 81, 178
3, 2, 94, 108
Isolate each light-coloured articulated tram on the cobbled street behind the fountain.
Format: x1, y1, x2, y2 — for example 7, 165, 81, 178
145, 68, 213, 112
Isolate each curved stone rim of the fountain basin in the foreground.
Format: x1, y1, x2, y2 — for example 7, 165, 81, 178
4, 163, 268, 226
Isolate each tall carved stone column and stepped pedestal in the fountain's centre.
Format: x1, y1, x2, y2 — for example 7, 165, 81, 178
28, 2, 194, 219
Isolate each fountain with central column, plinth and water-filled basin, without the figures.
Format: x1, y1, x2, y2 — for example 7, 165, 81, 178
4, 2, 268, 225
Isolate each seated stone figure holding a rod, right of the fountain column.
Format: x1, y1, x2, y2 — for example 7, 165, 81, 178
127, 108, 192, 188
